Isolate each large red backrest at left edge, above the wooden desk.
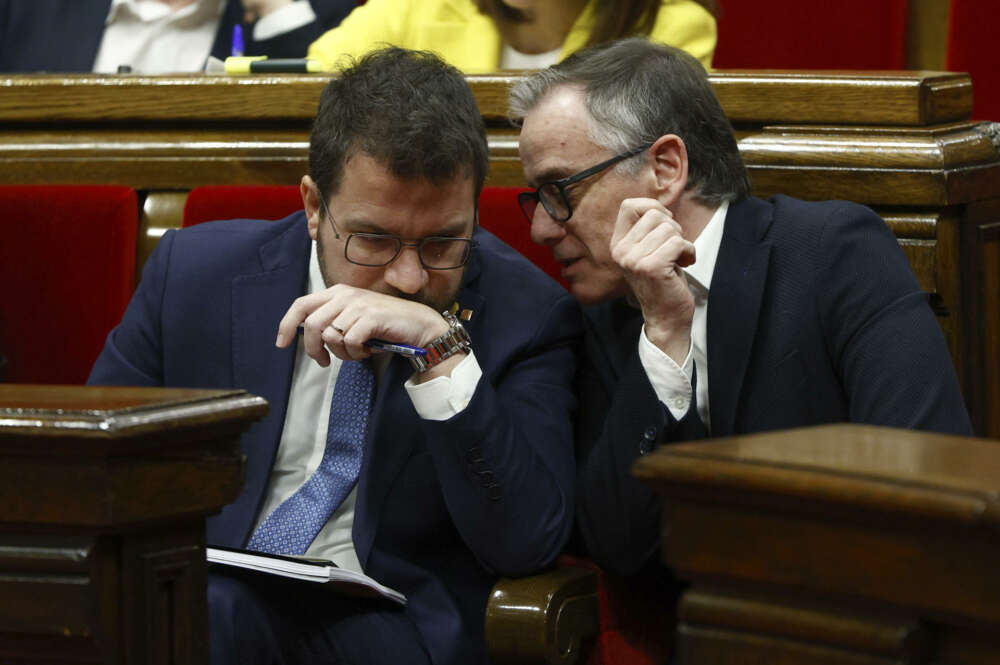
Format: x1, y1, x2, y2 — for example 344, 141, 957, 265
0, 185, 139, 384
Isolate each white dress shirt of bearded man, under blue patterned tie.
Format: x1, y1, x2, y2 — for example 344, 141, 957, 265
254, 243, 482, 572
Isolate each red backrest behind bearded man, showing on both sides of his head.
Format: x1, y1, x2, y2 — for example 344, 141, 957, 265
183, 185, 566, 286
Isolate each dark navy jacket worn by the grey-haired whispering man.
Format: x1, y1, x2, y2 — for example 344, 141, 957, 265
577, 196, 972, 574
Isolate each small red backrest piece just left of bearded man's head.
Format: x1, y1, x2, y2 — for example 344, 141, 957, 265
182, 185, 302, 227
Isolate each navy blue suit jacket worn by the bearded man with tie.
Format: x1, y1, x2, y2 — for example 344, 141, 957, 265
90, 212, 582, 664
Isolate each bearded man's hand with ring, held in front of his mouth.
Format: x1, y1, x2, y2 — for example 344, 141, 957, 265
275, 284, 461, 378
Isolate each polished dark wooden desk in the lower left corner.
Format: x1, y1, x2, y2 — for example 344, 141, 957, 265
0, 384, 268, 665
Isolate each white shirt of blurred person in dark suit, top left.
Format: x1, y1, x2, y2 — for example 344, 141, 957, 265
94, 0, 316, 74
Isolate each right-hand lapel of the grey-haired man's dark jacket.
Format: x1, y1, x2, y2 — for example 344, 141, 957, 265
707, 198, 772, 436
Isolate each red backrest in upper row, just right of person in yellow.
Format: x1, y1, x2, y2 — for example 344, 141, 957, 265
712, 0, 916, 69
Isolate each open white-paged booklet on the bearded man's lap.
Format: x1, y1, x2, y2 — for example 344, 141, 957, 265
206, 547, 406, 605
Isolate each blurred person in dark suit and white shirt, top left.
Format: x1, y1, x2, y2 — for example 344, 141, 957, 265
0, 0, 357, 74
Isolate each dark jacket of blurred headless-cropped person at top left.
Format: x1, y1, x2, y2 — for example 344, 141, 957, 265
0, 0, 357, 72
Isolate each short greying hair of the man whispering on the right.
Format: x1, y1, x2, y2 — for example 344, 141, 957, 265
510, 38, 750, 205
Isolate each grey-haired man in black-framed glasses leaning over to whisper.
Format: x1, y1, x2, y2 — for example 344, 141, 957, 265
511, 40, 971, 574
